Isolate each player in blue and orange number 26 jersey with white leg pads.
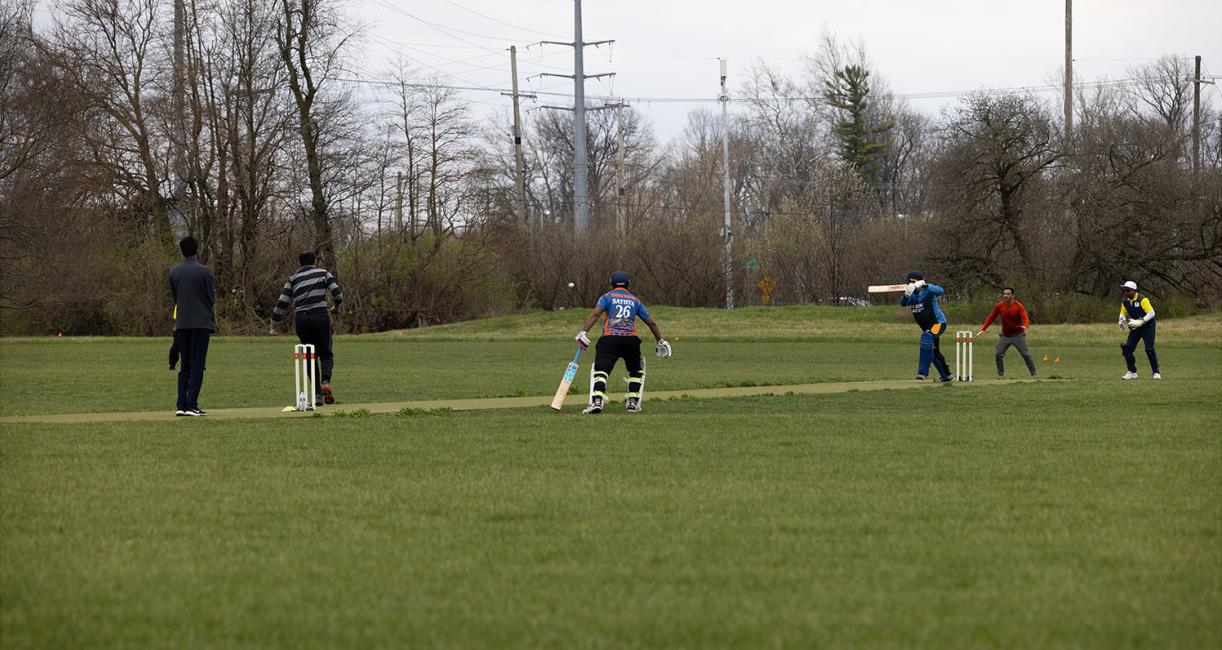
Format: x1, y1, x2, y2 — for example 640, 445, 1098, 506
577, 271, 671, 415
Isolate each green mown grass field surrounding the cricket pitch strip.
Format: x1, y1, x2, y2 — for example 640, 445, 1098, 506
0, 308, 1222, 649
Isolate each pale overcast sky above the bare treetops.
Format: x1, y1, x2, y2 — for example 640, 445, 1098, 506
40, 0, 1222, 142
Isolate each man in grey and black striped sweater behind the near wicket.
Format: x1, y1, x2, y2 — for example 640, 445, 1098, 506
271, 250, 343, 404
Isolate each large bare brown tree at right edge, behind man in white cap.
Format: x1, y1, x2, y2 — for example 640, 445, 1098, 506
1067, 82, 1222, 295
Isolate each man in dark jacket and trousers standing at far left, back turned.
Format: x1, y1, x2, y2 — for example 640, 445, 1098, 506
170, 236, 216, 417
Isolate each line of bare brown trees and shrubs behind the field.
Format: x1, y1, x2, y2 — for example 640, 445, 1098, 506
0, 0, 1222, 334
